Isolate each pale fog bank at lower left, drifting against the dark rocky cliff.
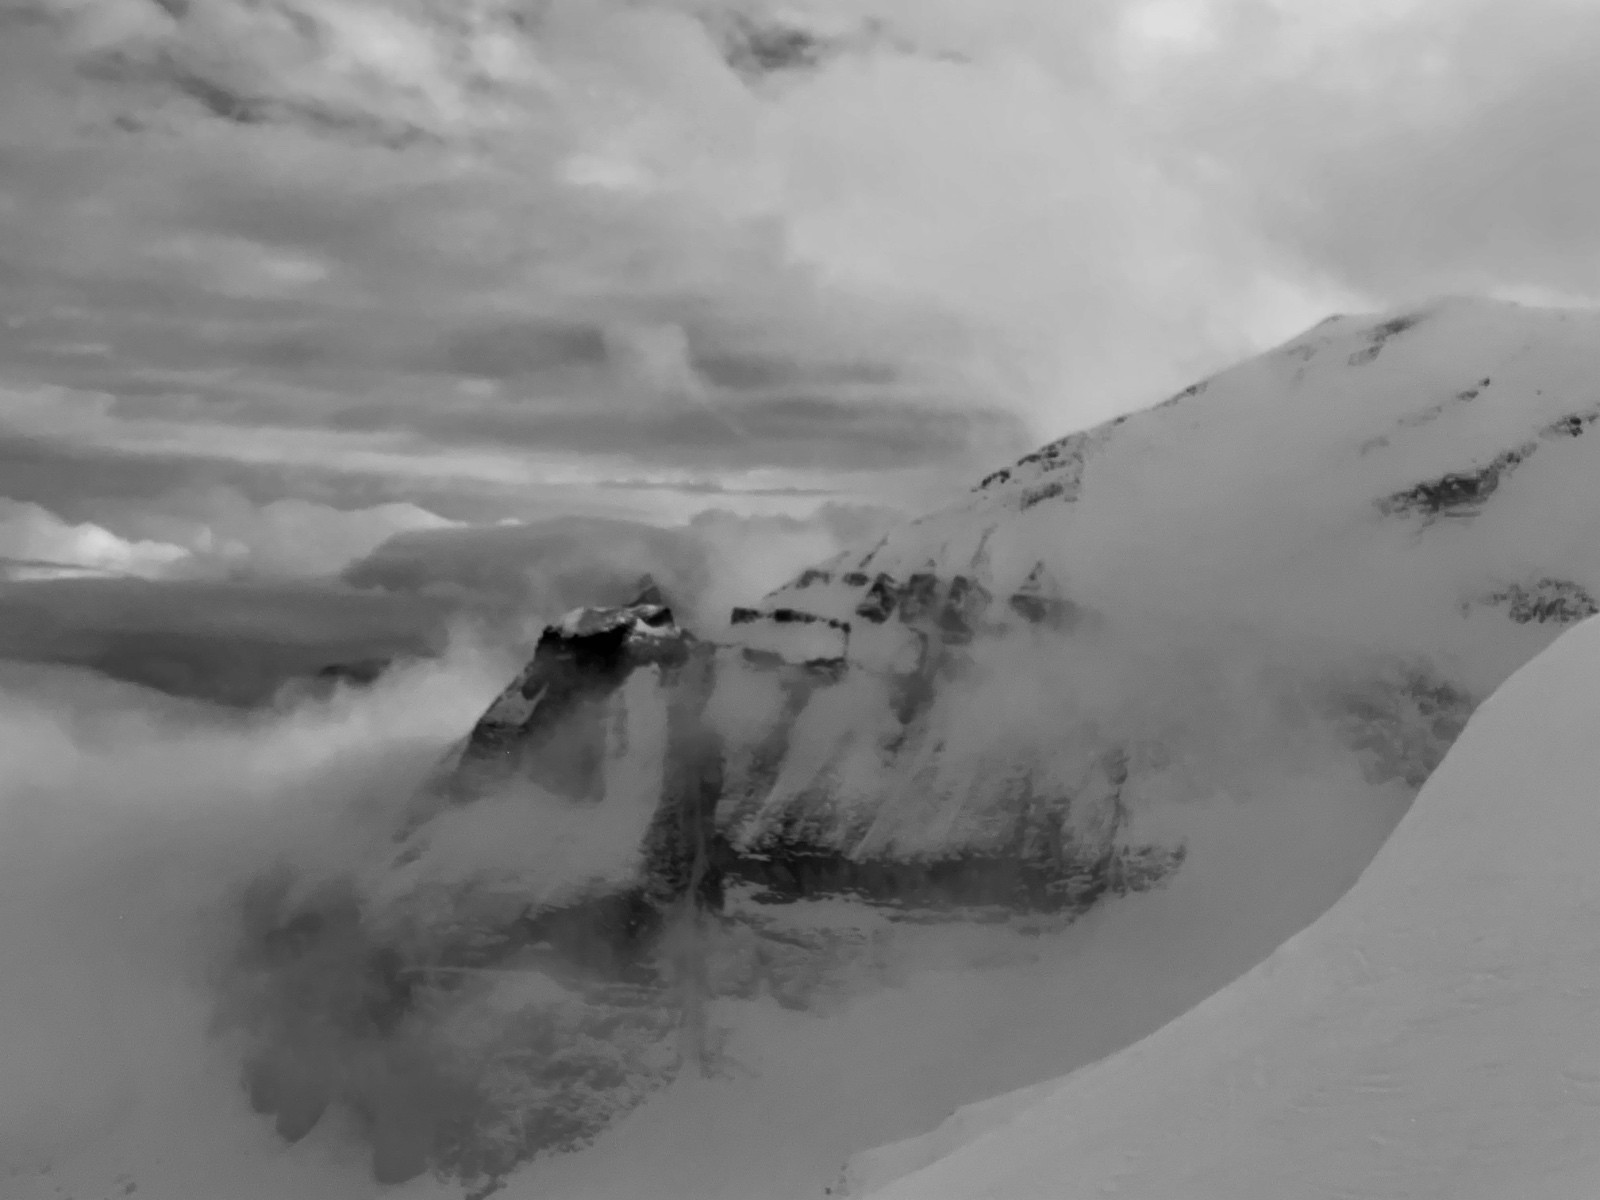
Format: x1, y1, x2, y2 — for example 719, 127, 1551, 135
0, 645, 504, 1177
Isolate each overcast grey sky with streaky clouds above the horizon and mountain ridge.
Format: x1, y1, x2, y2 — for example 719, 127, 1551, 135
0, 0, 1600, 588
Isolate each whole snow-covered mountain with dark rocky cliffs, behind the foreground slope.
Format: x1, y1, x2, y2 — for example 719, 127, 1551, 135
224, 299, 1600, 1200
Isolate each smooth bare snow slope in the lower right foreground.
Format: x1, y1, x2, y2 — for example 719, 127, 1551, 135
848, 621, 1600, 1200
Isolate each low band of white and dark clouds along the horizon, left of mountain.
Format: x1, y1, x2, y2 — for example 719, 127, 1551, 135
0, 486, 898, 706
